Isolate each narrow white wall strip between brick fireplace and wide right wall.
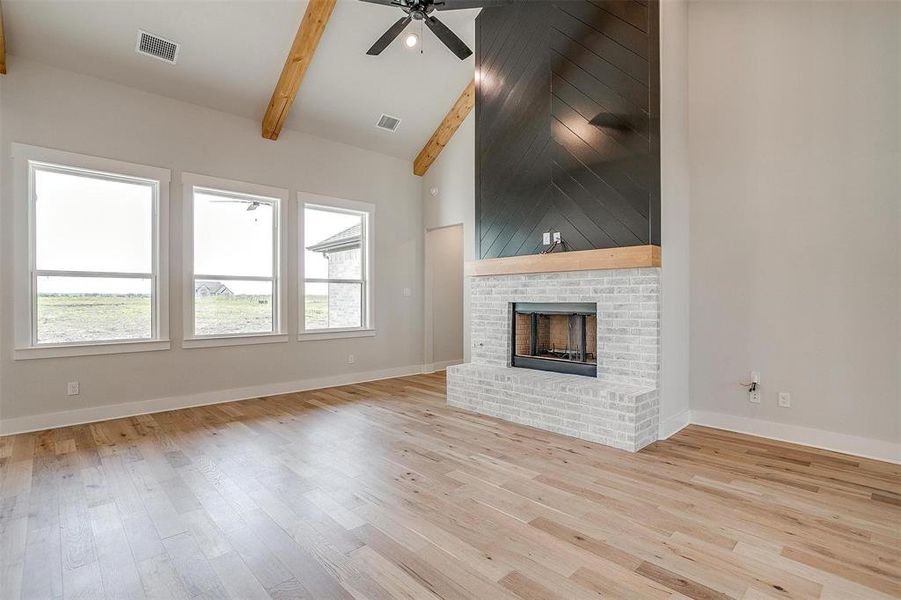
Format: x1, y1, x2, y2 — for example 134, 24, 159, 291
660, 0, 691, 437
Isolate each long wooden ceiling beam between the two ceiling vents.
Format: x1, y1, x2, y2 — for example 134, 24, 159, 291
263, 0, 337, 140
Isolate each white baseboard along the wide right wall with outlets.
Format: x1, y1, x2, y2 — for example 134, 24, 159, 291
691, 410, 901, 464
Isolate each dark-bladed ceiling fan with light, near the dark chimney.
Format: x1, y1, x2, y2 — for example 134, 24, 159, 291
363, 0, 510, 60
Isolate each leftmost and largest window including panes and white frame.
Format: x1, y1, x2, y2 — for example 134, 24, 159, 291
13, 144, 169, 358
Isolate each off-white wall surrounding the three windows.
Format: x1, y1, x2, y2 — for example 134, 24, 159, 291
0, 57, 423, 429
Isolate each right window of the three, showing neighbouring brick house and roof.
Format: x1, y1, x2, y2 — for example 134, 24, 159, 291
300, 194, 374, 336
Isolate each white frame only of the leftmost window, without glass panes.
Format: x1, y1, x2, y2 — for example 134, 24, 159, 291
12, 143, 170, 360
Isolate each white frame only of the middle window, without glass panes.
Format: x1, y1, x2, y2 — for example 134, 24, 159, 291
181, 173, 289, 348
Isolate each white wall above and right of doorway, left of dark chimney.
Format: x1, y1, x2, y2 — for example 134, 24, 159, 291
422, 112, 476, 362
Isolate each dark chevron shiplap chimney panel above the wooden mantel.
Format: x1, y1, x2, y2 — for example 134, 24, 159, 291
475, 0, 660, 258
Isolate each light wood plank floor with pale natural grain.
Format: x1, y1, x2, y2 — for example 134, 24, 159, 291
0, 374, 901, 600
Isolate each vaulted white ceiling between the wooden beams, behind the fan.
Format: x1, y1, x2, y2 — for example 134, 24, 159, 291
3, 0, 478, 160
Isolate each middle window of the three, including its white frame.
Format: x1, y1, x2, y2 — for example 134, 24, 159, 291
182, 174, 287, 347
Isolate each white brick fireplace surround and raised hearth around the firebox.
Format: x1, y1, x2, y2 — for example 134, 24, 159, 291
447, 268, 660, 451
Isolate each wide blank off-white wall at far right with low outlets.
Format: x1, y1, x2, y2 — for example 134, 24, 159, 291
684, 0, 901, 450
